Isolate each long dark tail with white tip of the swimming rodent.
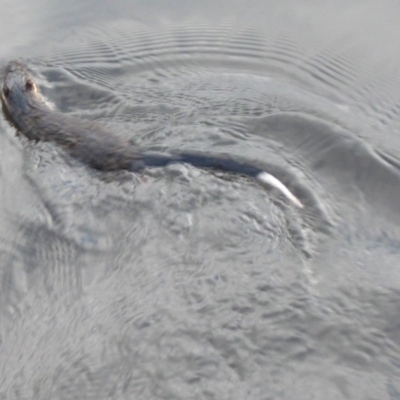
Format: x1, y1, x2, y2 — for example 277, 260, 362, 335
131, 152, 303, 208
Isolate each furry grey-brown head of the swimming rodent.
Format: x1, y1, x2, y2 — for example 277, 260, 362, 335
1, 62, 41, 127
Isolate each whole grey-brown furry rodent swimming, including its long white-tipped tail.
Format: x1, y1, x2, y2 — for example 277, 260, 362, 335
1, 62, 303, 207
